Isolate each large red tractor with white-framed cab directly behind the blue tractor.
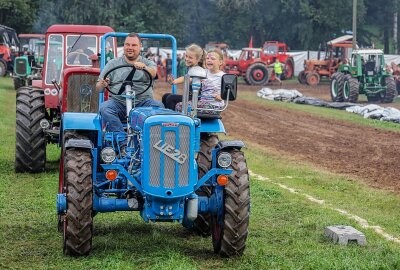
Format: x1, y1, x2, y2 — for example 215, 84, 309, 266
15, 25, 117, 172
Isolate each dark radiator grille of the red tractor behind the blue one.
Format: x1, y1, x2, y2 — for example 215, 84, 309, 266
67, 73, 99, 113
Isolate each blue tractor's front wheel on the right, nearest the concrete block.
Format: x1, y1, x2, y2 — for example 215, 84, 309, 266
212, 149, 250, 257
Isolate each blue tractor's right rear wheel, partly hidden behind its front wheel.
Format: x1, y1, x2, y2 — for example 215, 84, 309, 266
193, 134, 219, 237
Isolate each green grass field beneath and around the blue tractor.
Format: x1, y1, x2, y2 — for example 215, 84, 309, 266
0, 78, 400, 269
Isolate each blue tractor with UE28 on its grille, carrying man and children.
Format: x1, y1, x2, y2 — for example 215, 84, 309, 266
57, 33, 250, 257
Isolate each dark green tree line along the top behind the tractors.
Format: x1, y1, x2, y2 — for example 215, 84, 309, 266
0, 0, 400, 53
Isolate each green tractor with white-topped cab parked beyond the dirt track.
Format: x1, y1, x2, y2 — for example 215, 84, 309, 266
330, 49, 397, 103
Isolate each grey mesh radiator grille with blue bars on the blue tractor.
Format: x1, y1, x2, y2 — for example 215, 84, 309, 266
150, 125, 190, 188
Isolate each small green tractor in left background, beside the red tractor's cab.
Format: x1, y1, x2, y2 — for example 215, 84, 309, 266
13, 39, 45, 90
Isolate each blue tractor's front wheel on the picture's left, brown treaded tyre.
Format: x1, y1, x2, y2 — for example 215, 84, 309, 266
63, 148, 93, 256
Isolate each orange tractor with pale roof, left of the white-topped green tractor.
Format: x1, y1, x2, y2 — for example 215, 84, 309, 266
298, 35, 352, 86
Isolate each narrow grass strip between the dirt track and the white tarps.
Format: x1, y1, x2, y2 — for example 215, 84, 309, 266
240, 92, 400, 132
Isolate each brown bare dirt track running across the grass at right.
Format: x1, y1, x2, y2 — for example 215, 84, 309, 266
157, 82, 400, 192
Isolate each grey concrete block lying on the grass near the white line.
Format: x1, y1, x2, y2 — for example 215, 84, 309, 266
325, 225, 367, 246
